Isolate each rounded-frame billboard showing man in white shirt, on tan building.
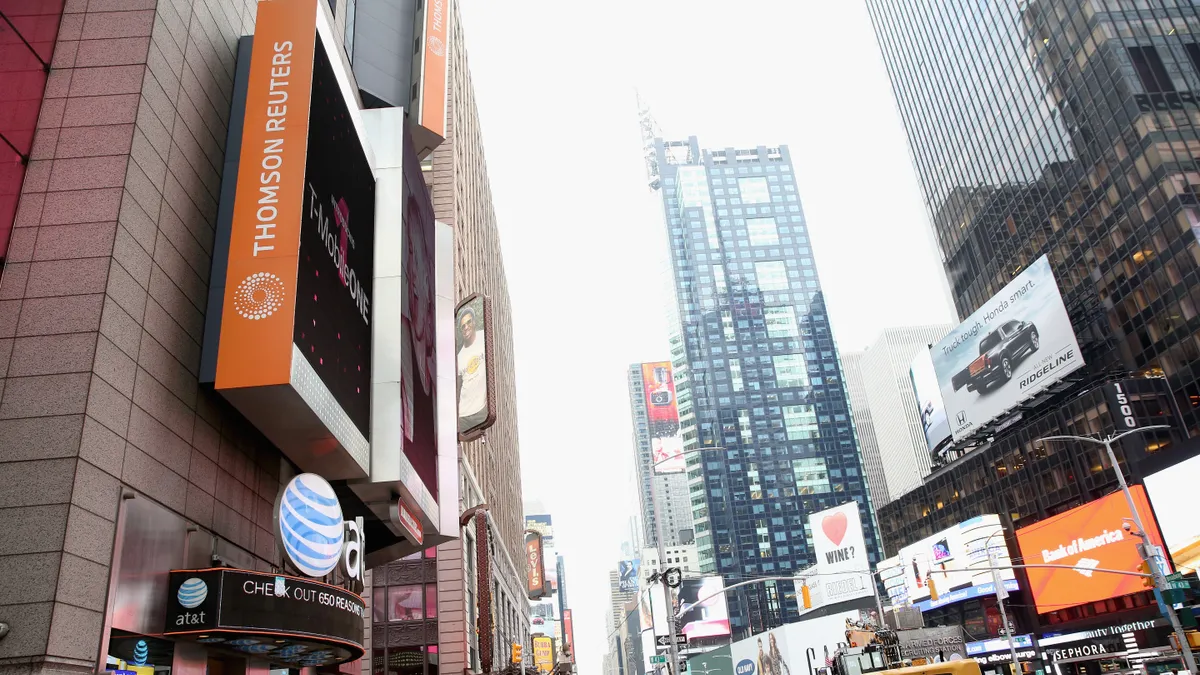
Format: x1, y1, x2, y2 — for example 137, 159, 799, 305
454, 294, 496, 441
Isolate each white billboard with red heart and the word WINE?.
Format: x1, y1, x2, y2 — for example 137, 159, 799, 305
800, 501, 875, 605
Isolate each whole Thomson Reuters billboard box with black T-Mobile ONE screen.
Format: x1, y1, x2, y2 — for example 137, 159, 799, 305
212, 0, 376, 478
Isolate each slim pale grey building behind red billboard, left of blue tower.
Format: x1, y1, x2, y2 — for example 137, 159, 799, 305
629, 364, 695, 546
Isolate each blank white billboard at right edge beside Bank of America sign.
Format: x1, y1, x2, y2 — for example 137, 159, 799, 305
1141, 449, 1200, 572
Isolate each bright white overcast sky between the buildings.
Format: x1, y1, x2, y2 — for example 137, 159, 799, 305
462, 0, 954, 675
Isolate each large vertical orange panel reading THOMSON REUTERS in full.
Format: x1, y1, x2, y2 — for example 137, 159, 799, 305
216, 0, 317, 389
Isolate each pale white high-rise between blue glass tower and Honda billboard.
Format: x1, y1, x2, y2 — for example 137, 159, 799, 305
856, 323, 954, 508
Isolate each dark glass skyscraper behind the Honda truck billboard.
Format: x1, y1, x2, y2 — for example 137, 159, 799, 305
868, 0, 1200, 437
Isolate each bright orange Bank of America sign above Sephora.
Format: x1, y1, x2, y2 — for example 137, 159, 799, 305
1016, 485, 1163, 614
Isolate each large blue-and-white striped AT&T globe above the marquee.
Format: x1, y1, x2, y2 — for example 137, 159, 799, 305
275, 473, 346, 577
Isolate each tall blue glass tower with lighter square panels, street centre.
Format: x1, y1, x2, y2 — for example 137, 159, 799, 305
647, 137, 877, 633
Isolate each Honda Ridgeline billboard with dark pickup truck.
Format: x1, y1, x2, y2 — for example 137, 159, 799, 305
930, 256, 1084, 441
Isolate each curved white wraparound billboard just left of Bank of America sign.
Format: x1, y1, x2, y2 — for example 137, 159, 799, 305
878, 514, 1018, 611
